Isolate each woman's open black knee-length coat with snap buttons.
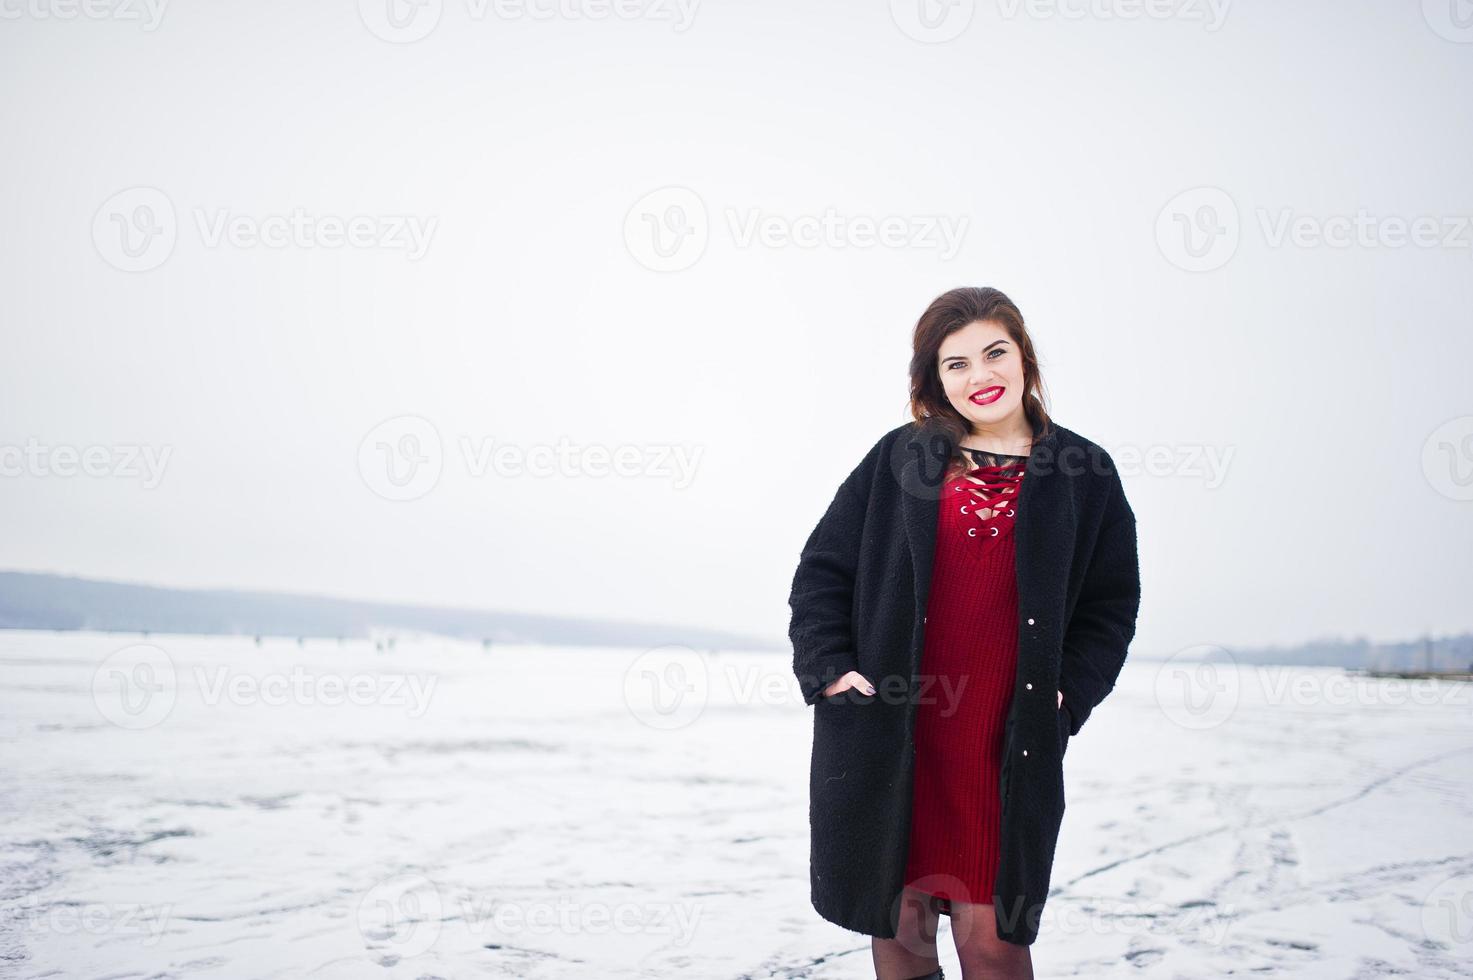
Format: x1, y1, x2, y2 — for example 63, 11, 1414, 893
788, 423, 1140, 946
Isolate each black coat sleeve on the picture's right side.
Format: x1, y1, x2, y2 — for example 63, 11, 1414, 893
1059, 467, 1140, 735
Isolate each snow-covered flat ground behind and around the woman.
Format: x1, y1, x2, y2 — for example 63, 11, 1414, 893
0, 632, 1473, 980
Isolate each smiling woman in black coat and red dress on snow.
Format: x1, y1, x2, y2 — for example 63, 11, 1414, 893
788, 287, 1140, 980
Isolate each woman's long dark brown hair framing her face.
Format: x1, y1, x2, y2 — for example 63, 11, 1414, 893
910, 286, 1052, 463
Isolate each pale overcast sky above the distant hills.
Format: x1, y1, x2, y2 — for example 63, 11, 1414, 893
0, 0, 1473, 654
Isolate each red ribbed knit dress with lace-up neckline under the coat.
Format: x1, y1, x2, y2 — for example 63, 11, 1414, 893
906, 454, 1027, 912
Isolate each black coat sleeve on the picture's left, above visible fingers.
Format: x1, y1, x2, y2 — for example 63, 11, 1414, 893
788, 470, 868, 704
